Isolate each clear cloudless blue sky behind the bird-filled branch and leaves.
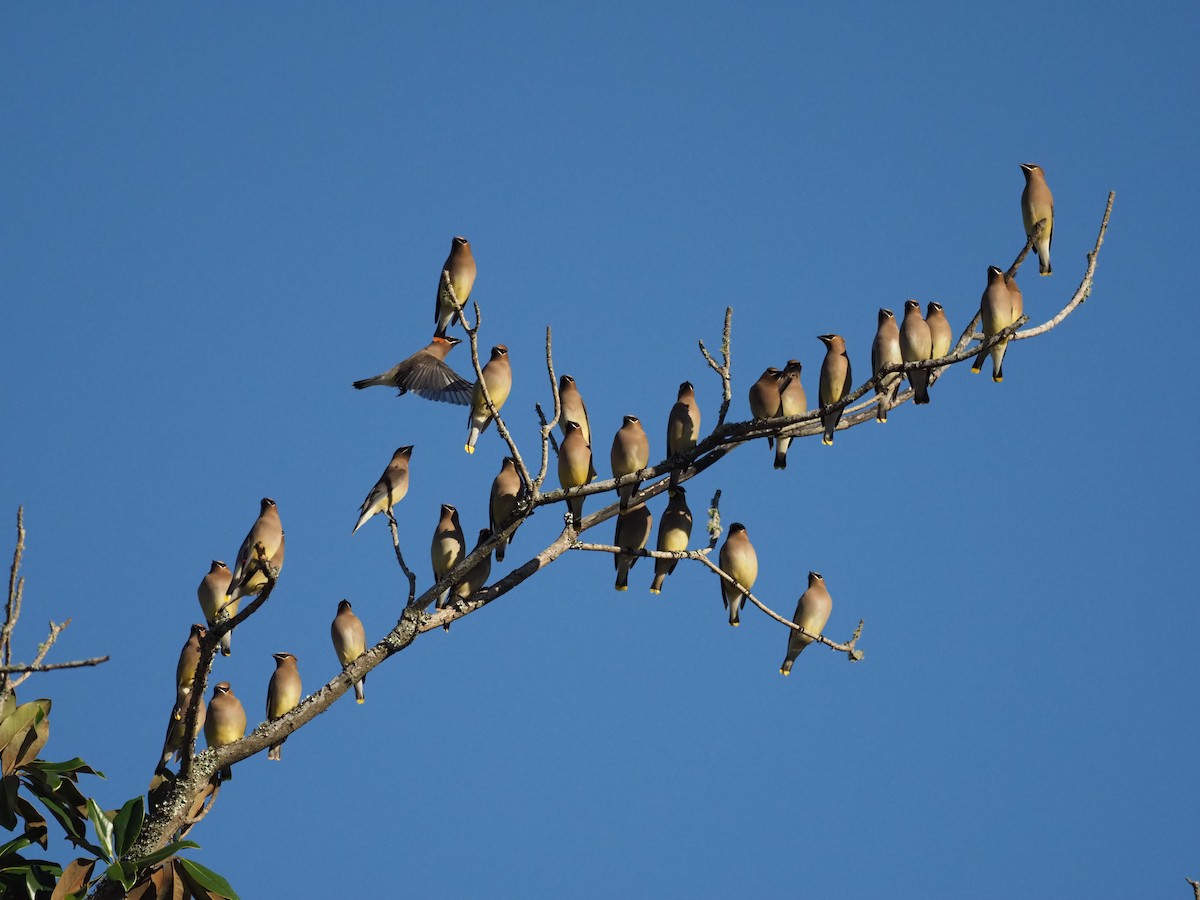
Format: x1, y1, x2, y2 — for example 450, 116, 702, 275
0, 2, 1200, 898
